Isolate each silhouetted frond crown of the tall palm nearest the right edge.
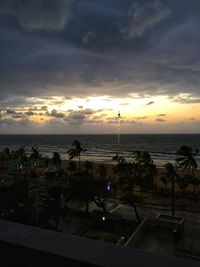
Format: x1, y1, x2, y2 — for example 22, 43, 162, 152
176, 145, 199, 176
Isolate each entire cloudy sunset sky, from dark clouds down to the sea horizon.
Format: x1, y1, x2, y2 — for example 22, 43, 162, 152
0, 0, 200, 134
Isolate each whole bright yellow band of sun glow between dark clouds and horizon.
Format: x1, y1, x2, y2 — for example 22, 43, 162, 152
1, 95, 200, 132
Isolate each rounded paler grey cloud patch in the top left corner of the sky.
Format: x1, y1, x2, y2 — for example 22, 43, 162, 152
1, 0, 72, 31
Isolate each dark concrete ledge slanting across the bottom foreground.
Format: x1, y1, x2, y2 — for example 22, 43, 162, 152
0, 221, 200, 267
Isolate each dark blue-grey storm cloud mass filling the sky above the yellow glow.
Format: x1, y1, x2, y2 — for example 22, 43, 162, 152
0, 0, 200, 101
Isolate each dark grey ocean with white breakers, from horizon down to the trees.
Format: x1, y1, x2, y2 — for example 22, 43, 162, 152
0, 134, 200, 167
